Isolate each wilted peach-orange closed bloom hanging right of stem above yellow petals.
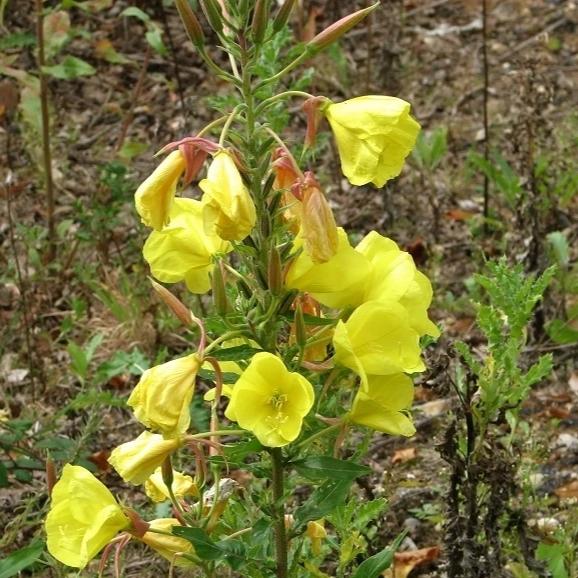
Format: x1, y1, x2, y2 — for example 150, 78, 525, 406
301, 173, 339, 263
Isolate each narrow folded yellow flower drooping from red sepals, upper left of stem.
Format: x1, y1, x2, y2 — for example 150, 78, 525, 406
134, 150, 185, 231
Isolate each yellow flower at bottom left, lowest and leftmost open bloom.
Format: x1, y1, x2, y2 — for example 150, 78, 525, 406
45, 464, 130, 568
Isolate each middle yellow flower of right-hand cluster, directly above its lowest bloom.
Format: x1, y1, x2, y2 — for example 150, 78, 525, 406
333, 301, 425, 386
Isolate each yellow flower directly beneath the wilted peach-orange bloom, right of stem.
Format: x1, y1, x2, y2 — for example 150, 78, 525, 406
285, 228, 370, 309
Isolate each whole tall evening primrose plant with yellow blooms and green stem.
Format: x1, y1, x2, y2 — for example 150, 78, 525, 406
46, 0, 439, 578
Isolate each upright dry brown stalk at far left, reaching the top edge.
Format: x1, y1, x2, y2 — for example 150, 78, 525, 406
36, 0, 56, 262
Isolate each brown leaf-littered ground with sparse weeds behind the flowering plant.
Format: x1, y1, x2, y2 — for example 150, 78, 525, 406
0, 0, 578, 577
